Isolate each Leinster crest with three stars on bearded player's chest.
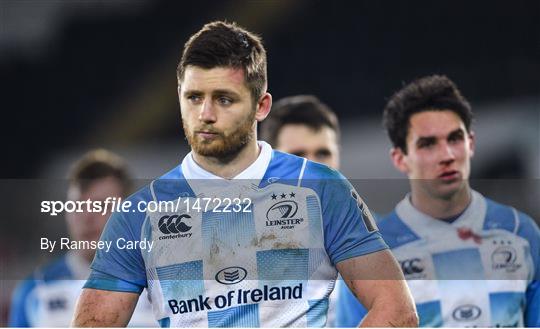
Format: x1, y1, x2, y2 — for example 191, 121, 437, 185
266, 192, 304, 229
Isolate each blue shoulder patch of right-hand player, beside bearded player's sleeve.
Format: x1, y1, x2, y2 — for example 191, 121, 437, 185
376, 210, 419, 249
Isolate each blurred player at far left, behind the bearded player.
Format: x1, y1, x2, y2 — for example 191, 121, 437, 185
9, 150, 157, 327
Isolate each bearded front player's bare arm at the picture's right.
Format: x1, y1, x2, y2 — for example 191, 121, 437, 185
337, 250, 418, 327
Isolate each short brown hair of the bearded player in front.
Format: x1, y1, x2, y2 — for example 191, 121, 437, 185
176, 21, 267, 101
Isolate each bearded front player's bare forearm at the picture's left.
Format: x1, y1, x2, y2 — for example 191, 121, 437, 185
71, 288, 139, 327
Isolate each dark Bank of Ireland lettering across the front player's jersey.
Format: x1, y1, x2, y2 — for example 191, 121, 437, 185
167, 283, 303, 314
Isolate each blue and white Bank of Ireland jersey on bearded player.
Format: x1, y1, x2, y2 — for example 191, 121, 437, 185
86, 142, 387, 327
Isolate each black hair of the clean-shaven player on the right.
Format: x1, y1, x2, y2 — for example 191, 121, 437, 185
383, 75, 473, 153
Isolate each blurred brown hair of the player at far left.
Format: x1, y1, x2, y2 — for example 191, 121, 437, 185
69, 149, 131, 195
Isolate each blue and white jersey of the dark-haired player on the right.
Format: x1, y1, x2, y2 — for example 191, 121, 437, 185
336, 191, 540, 327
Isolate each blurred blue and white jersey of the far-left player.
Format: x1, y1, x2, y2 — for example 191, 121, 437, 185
8, 252, 157, 327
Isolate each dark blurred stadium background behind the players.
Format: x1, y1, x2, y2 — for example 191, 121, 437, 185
0, 0, 540, 326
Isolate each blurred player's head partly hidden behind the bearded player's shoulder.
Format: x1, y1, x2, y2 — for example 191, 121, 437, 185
261, 95, 339, 170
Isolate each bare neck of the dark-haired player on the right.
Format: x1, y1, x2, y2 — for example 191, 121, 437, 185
411, 184, 471, 219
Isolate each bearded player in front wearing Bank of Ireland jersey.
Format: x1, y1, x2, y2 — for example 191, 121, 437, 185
73, 22, 416, 327
